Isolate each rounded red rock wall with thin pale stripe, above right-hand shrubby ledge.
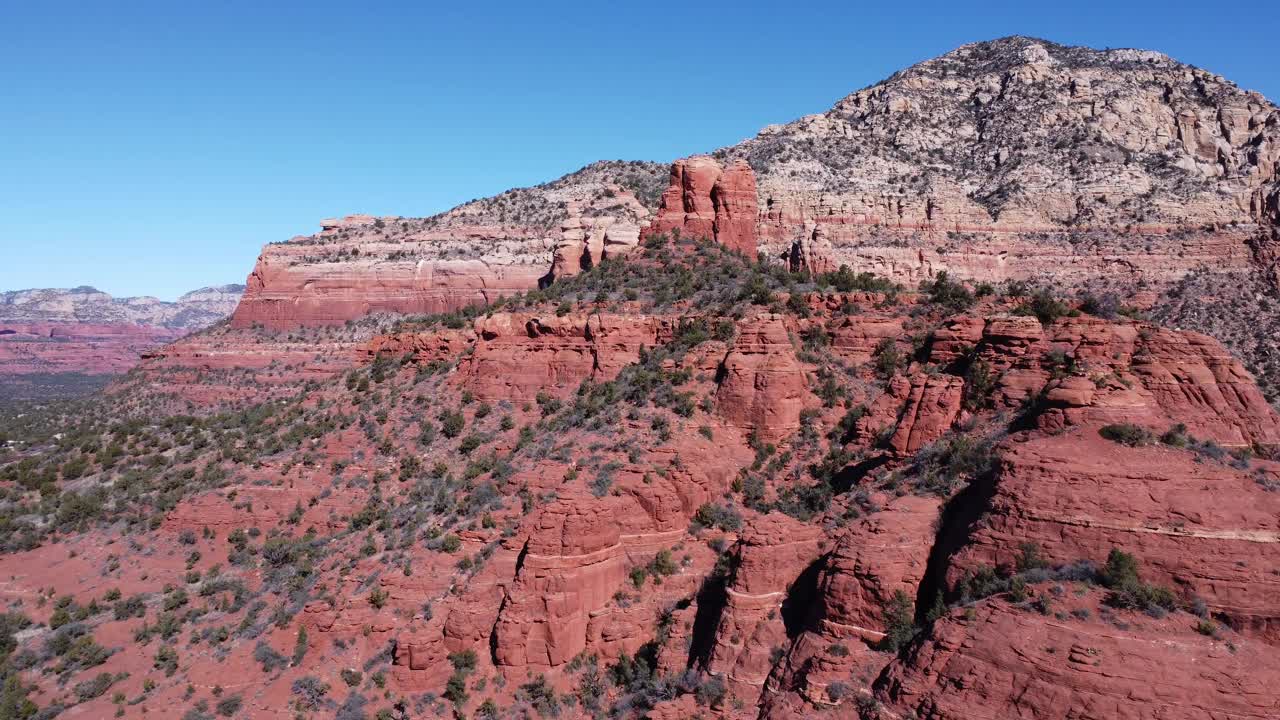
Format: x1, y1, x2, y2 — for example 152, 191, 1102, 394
948, 427, 1280, 643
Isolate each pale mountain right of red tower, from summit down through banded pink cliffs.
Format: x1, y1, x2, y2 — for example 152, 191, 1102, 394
726, 37, 1280, 284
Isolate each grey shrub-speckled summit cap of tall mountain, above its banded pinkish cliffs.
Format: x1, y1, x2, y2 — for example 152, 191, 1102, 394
719, 36, 1280, 234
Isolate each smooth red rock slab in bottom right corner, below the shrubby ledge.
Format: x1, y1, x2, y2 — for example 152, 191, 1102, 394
876, 588, 1280, 720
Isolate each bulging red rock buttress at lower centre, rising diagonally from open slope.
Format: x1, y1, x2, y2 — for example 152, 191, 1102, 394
463, 427, 749, 669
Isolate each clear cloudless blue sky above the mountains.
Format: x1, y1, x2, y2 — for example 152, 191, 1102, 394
0, 0, 1280, 299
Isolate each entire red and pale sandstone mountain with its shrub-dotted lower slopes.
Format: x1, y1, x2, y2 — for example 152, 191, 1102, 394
0, 38, 1280, 720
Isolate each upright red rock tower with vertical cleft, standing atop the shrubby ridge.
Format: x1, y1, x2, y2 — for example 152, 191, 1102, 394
644, 156, 759, 258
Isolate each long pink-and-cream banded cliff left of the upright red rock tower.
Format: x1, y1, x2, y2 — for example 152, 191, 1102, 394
232, 163, 660, 329
